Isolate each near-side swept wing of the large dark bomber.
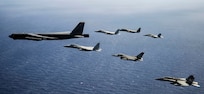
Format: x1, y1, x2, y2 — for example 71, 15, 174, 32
26, 33, 56, 40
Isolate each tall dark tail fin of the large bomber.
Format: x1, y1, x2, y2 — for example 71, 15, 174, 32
71, 22, 85, 35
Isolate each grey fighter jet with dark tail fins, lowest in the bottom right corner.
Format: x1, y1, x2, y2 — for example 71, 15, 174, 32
156, 75, 200, 87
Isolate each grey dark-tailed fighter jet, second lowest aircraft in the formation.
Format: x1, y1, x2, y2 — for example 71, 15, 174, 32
113, 52, 144, 61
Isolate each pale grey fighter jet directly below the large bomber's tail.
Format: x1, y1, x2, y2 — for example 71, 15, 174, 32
64, 43, 101, 51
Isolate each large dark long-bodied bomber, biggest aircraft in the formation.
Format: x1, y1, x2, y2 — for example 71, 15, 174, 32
9, 22, 89, 41
